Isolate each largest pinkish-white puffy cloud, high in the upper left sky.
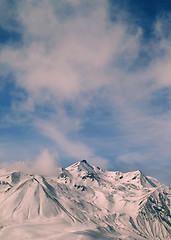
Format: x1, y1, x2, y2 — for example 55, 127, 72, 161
0, 1, 140, 108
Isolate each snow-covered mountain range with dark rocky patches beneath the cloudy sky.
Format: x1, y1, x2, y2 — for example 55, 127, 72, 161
0, 160, 171, 240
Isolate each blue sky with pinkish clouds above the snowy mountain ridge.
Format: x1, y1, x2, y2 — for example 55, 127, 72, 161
0, 0, 171, 185
